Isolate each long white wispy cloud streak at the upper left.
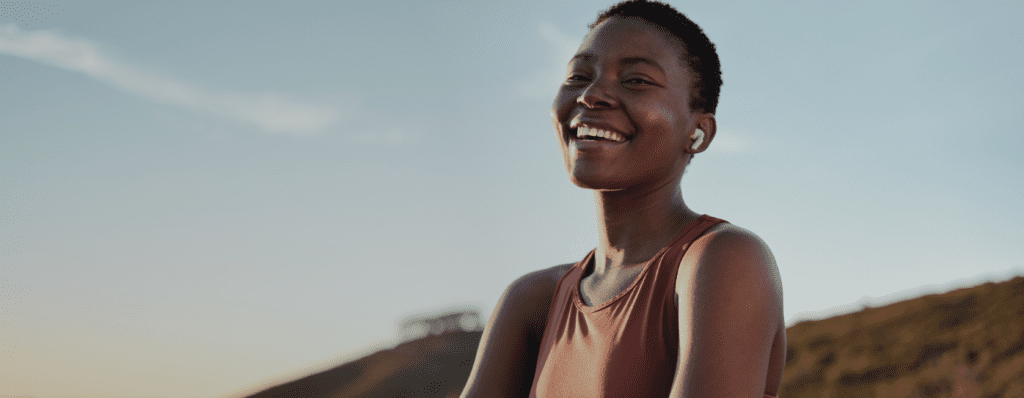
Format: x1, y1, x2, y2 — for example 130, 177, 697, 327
0, 24, 341, 134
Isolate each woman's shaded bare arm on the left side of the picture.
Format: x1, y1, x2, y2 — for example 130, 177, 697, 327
462, 264, 571, 398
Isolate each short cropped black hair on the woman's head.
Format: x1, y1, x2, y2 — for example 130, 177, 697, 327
589, 0, 722, 114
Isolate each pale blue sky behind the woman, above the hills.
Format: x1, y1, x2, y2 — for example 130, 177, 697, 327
0, 0, 1024, 398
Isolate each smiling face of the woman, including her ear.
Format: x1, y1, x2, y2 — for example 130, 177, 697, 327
552, 17, 714, 190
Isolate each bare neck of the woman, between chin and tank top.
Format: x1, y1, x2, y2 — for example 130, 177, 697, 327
594, 183, 699, 275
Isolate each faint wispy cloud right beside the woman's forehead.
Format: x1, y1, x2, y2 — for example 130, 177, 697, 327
516, 23, 582, 99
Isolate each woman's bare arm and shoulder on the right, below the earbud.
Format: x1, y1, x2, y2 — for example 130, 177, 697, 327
670, 225, 785, 398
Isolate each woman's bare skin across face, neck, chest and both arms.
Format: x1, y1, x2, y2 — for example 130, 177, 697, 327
462, 17, 785, 398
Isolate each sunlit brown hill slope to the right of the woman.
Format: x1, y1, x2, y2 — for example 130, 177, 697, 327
781, 276, 1024, 398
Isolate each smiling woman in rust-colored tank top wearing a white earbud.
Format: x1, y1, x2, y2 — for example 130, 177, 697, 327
463, 1, 785, 398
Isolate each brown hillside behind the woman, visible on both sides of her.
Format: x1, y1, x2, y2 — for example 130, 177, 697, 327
251, 277, 1024, 398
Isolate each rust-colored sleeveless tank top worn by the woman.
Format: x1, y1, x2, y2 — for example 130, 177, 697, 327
529, 215, 775, 398
